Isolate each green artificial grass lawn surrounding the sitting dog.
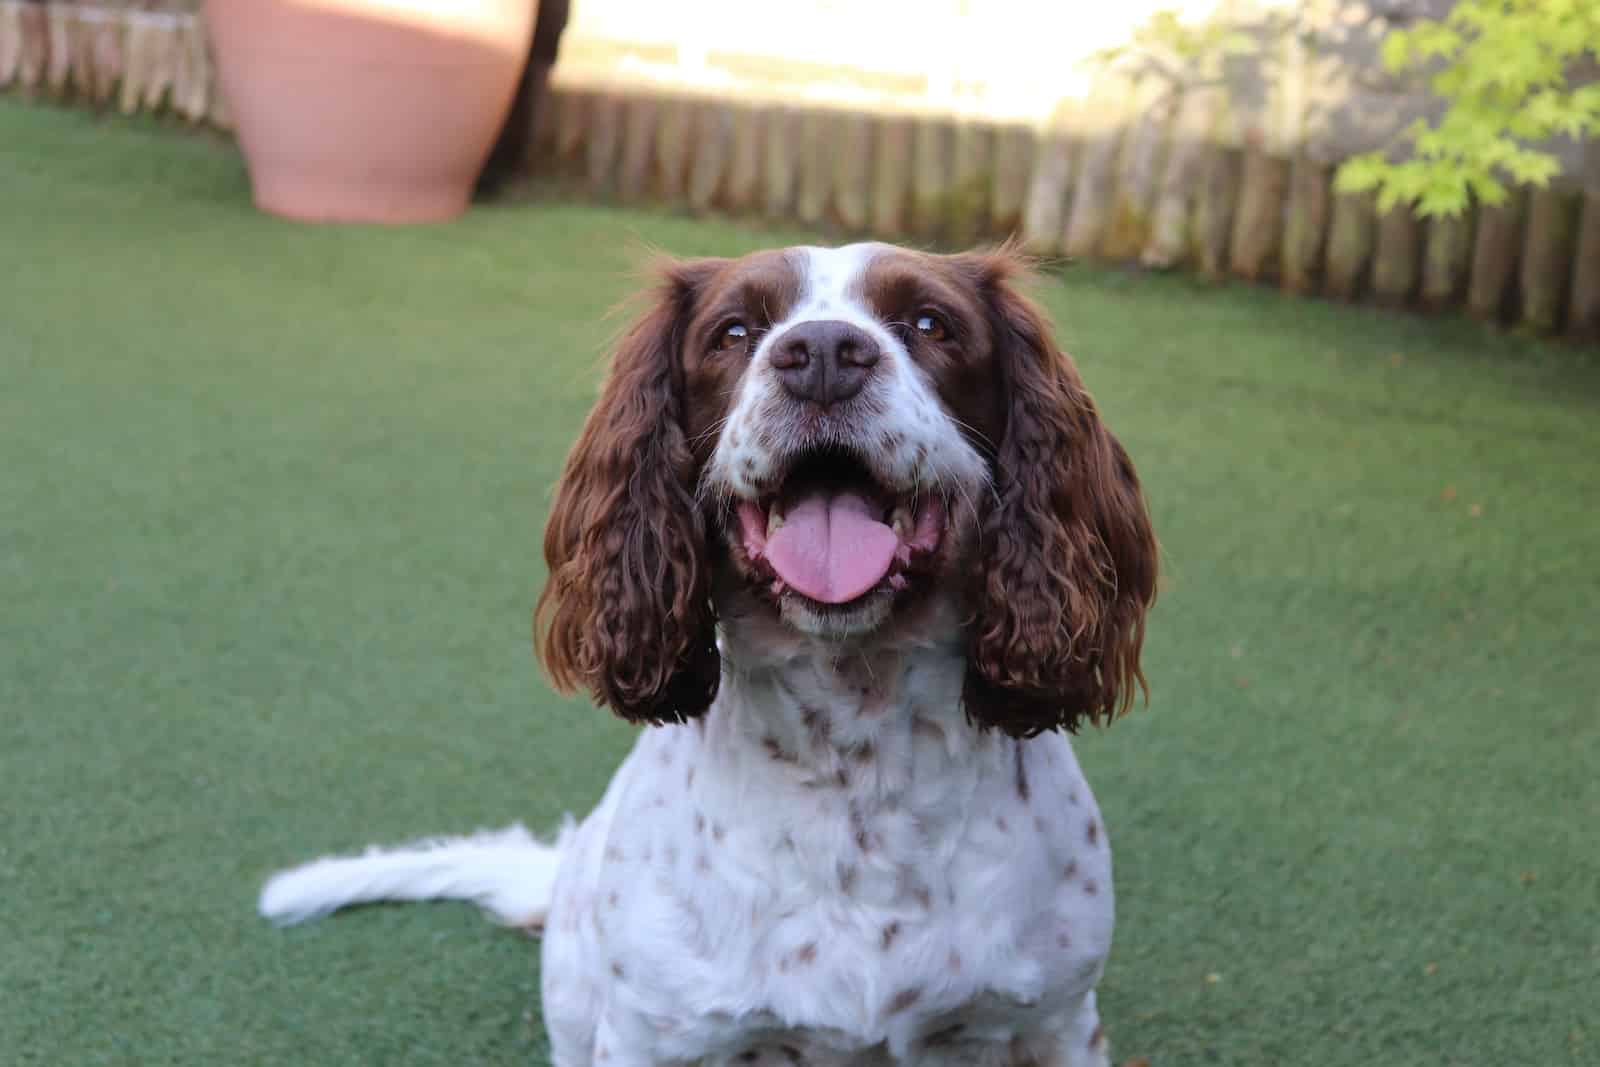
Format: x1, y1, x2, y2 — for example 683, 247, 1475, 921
0, 101, 1600, 1067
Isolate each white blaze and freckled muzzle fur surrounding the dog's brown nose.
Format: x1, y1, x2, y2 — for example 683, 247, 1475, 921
706, 242, 987, 501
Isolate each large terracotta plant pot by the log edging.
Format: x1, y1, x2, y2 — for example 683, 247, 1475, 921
205, 0, 538, 222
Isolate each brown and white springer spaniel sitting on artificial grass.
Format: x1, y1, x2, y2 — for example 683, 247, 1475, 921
261, 245, 1157, 1067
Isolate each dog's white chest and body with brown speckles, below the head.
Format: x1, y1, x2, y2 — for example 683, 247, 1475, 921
542, 627, 1112, 1067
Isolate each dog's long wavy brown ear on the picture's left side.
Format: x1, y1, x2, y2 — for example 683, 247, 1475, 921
534, 261, 722, 723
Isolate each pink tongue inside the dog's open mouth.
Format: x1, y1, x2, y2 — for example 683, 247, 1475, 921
766, 490, 899, 603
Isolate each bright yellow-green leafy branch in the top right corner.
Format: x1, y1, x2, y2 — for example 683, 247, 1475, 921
1338, 0, 1600, 216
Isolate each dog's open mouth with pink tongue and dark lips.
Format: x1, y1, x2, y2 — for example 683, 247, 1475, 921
738, 448, 946, 605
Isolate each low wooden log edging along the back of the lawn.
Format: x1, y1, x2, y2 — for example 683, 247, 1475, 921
0, 0, 1600, 339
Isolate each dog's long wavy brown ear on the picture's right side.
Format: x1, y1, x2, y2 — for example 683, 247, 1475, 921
962, 253, 1158, 737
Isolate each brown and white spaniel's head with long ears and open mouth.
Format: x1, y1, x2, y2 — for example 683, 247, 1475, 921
538, 245, 1157, 736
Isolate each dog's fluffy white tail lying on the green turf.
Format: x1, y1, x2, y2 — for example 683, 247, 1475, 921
259, 824, 568, 926
